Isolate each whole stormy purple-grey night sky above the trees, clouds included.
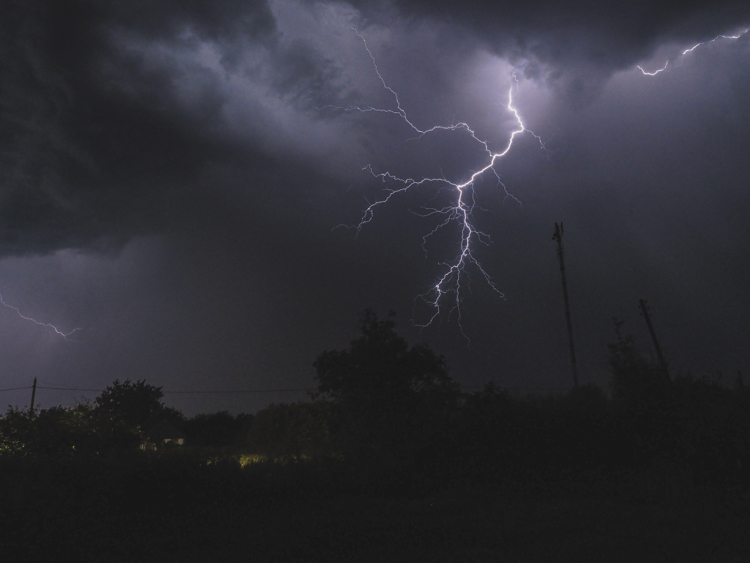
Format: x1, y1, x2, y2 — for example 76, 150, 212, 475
0, 0, 750, 415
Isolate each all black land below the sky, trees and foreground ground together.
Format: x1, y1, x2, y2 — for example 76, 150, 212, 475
0, 311, 750, 561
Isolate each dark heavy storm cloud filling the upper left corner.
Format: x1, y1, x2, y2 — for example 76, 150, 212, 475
0, 1, 276, 254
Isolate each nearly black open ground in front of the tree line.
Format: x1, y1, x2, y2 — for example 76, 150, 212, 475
0, 456, 750, 563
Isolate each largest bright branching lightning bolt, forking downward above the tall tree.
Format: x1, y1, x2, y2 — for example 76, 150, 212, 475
326, 28, 546, 334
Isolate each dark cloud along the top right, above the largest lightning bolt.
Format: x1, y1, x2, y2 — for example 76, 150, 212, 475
354, 0, 750, 100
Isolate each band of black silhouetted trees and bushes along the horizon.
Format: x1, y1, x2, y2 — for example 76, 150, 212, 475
0, 310, 750, 494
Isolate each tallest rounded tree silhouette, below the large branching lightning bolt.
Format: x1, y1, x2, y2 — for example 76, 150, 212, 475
313, 309, 459, 464
